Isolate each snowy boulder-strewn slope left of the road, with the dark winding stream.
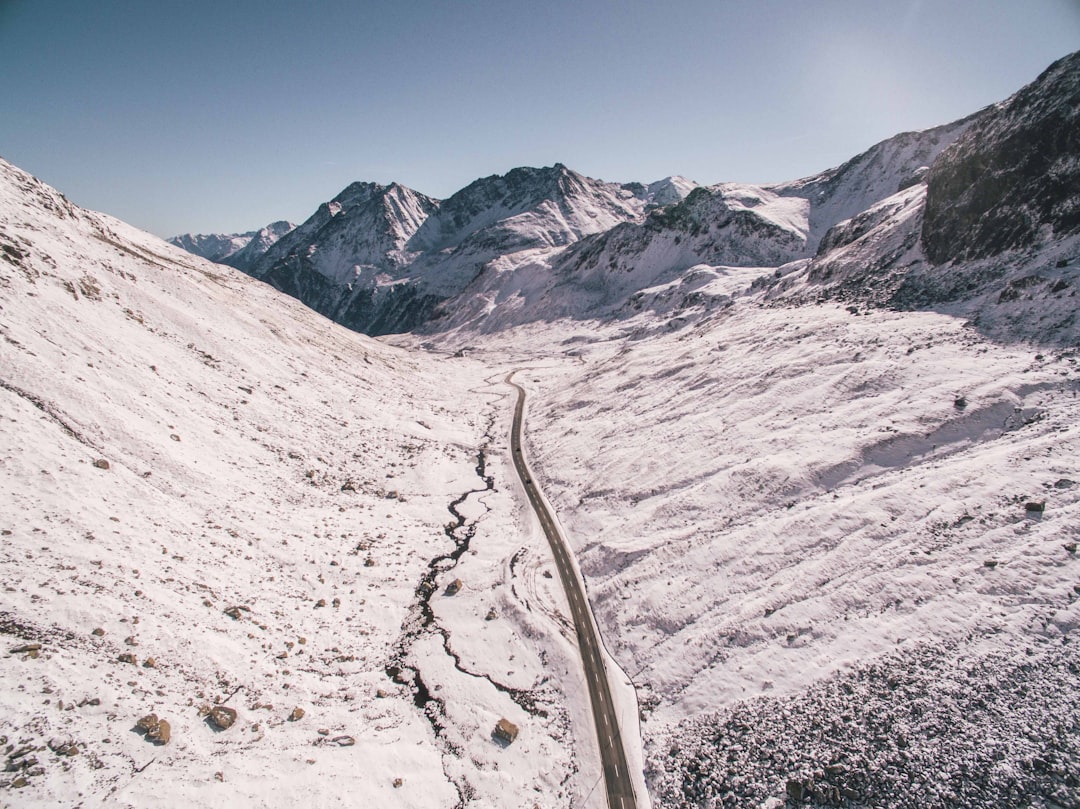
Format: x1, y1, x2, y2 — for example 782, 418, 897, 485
0, 163, 613, 807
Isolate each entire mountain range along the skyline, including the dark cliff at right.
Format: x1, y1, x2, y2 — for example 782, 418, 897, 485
171, 54, 1080, 335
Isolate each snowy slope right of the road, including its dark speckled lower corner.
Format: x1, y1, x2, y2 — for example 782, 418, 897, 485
451, 289, 1080, 807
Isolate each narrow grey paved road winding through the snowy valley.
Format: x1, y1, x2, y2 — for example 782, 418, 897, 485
507, 373, 637, 809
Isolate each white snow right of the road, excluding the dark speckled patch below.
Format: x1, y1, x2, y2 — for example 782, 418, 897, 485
436, 287, 1080, 805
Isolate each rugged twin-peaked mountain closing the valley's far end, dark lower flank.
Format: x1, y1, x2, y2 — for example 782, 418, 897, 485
243, 164, 673, 334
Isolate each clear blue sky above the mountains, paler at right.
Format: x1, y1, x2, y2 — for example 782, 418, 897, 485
0, 0, 1080, 235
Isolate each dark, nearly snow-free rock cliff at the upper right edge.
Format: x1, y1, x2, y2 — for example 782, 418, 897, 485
922, 52, 1080, 265
